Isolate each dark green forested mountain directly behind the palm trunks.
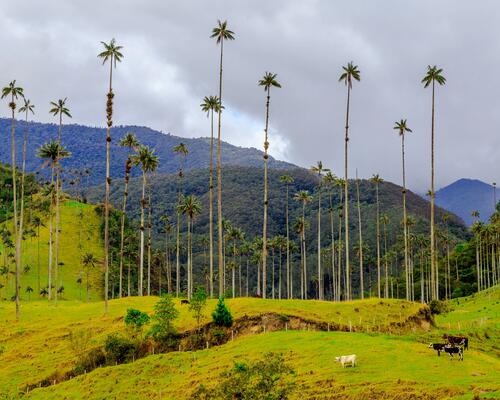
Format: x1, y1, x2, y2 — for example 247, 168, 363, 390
86, 167, 467, 252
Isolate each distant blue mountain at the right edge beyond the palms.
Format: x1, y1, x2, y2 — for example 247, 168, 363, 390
436, 179, 498, 225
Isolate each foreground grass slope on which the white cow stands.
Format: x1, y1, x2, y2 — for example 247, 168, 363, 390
28, 331, 500, 399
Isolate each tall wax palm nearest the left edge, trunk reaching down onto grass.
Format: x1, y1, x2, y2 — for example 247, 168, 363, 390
2, 80, 24, 320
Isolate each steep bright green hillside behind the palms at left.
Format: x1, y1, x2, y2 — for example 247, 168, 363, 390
0, 200, 104, 300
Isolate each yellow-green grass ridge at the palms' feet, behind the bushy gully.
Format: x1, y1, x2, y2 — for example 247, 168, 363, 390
0, 297, 420, 398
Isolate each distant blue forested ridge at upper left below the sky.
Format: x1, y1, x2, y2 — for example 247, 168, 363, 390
0, 118, 295, 186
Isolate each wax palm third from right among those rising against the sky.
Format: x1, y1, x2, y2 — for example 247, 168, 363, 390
339, 62, 360, 300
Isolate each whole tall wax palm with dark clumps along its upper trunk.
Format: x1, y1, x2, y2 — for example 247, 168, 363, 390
97, 38, 124, 314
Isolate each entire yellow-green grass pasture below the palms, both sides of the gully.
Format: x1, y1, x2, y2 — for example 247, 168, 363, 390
0, 287, 500, 399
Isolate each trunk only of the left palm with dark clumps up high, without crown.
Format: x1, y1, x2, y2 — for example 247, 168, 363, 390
104, 56, 114, 314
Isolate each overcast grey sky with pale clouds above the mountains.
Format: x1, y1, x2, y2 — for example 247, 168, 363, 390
0, 0, 500, 192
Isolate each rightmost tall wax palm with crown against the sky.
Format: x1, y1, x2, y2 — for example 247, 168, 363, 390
422, 65, 446, 300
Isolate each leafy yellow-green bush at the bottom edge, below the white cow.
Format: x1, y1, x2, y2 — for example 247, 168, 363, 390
194, 353, 295, 400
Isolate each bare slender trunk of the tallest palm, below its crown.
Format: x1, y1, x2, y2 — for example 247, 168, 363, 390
217, 40, 224, 297
